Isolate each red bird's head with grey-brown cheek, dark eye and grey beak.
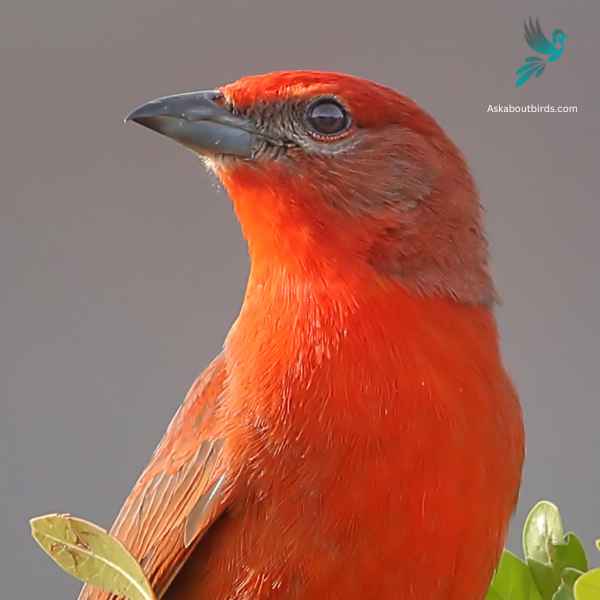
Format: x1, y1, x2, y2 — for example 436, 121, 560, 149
128, 71, 494, 304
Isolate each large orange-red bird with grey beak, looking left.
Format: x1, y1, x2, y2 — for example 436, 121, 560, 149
81, 71, 523, 600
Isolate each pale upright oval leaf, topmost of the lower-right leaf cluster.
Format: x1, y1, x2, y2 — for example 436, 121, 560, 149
523, 500, 564, 564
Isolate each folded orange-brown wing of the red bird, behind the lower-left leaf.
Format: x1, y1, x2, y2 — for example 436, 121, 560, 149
79, 355, 237, 600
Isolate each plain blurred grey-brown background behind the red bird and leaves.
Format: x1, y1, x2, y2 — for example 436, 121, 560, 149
0, 0, 600, 600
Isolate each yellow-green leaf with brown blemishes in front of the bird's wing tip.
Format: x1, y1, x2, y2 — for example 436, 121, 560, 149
30, 514, 156, 600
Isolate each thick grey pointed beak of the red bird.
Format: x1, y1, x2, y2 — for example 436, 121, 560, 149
125, 91, 257, 158
